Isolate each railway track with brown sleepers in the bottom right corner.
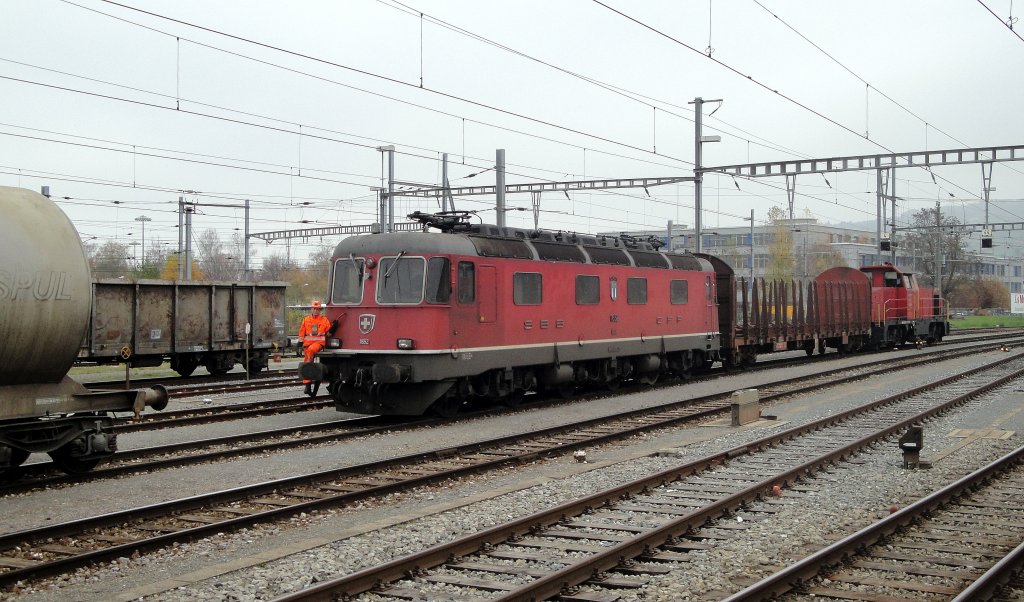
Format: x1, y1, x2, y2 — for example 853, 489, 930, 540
727, 447, 1024, 602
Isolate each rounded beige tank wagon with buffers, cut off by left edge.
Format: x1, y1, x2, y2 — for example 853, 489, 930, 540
0, 186, 167, 478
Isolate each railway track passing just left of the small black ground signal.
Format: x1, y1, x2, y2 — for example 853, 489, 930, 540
274, 355, 1024, 602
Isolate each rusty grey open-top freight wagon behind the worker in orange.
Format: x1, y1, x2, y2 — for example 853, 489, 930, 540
79, 280, 287, 376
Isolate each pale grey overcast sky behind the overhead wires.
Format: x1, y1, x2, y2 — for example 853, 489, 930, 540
0, 0, 1024, 266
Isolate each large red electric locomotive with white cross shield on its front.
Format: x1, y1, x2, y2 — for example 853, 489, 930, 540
302, 213, 722, 415
